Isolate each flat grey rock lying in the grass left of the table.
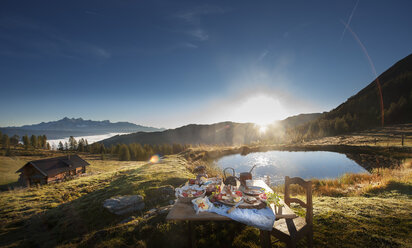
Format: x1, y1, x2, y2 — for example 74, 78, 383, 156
103, 195, 144, 215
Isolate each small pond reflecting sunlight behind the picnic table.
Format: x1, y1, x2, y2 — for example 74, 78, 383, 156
217, 151, 367, 184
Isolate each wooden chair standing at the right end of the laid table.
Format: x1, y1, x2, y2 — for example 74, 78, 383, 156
271, 177, 313, 247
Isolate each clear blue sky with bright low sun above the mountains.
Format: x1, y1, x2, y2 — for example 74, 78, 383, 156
0, 0, 412, 128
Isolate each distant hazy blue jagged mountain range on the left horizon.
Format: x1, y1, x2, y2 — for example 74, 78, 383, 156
0, 117, 164, 139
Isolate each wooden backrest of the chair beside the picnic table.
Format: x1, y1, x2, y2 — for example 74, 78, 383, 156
285, 176, 313, 224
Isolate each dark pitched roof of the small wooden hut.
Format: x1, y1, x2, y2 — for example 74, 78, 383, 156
16, 155, 89, 177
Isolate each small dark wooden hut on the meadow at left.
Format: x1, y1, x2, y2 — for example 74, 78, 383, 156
16, 155, 89, 186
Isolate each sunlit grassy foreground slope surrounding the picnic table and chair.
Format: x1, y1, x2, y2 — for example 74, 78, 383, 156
0, 152, 412, 247
